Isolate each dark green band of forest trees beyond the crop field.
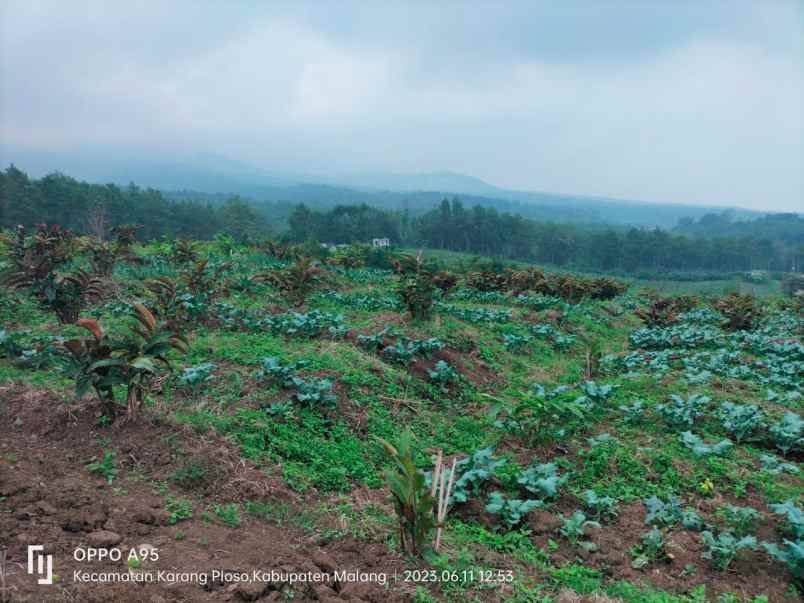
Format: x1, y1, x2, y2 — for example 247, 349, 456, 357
0, 166, 804, 274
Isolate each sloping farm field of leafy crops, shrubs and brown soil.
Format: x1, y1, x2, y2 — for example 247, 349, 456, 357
0, 229, 804, 603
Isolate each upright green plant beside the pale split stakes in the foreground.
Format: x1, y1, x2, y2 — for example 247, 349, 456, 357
379, 432, 436, 555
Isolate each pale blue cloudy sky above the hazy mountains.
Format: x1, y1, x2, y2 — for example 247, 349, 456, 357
0, 0, 804, 211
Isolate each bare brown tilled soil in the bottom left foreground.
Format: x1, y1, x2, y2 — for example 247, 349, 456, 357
0, 385, 411, 603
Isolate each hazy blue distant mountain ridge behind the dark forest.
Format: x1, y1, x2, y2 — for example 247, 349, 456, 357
0, 147, 765, 228
